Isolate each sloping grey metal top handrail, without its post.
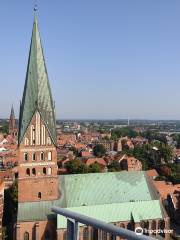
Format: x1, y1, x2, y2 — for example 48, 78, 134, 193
51, 207, 155, 240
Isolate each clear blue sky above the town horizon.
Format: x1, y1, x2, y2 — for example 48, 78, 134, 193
0, 0, 180, 119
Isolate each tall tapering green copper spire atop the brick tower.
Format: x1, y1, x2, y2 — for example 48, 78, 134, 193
19, 16, 56, 143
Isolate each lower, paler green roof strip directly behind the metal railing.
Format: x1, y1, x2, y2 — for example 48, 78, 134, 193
57, 200, 163, 229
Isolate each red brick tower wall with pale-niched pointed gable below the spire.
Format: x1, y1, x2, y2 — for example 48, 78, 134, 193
18, 112, 59, 202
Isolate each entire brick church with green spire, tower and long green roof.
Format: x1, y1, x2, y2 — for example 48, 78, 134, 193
14, 12, 169, 240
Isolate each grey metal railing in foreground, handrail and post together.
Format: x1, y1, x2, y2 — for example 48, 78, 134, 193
51, 207, 155, 240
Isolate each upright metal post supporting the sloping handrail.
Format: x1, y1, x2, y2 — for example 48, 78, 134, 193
67, 218, 79, 240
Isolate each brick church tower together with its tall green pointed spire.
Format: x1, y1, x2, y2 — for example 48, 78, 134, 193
18, 16, 59, 203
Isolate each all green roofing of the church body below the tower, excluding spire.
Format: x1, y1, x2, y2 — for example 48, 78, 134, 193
18, 171, 164, 223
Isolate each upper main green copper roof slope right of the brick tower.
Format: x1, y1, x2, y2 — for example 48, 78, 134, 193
60, 171, 154, 207
